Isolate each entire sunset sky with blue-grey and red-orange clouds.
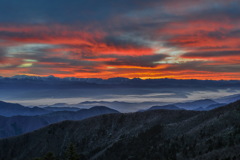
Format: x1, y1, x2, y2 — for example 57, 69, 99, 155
0, 0, 240, 80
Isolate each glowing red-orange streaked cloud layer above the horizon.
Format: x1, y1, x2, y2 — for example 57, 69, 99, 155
0, 20, 240, 80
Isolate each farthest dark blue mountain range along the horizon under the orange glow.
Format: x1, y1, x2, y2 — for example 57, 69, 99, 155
0, 75, 240, 89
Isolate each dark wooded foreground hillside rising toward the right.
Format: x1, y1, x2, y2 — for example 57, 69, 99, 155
0, 101, 240, 160
